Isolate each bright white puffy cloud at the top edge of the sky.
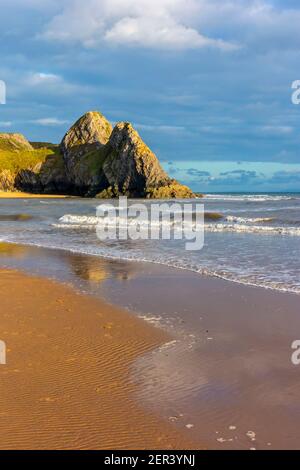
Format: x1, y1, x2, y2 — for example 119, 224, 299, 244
43, 0, 237, 50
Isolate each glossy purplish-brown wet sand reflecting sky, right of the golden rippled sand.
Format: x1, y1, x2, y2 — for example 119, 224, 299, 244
102, 265, 300, 450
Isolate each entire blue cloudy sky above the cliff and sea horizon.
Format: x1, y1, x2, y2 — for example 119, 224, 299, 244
0, 0, 300, 192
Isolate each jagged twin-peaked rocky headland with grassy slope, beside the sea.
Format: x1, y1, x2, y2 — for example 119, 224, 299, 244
0, 112, 193, 198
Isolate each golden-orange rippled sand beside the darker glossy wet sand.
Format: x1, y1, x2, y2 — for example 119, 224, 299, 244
0, 270, 195, 449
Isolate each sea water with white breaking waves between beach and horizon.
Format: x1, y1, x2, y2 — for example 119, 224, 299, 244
0, 194, 300, 293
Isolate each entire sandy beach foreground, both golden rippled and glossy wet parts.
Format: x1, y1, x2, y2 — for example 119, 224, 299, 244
0, 243, 300, 449
